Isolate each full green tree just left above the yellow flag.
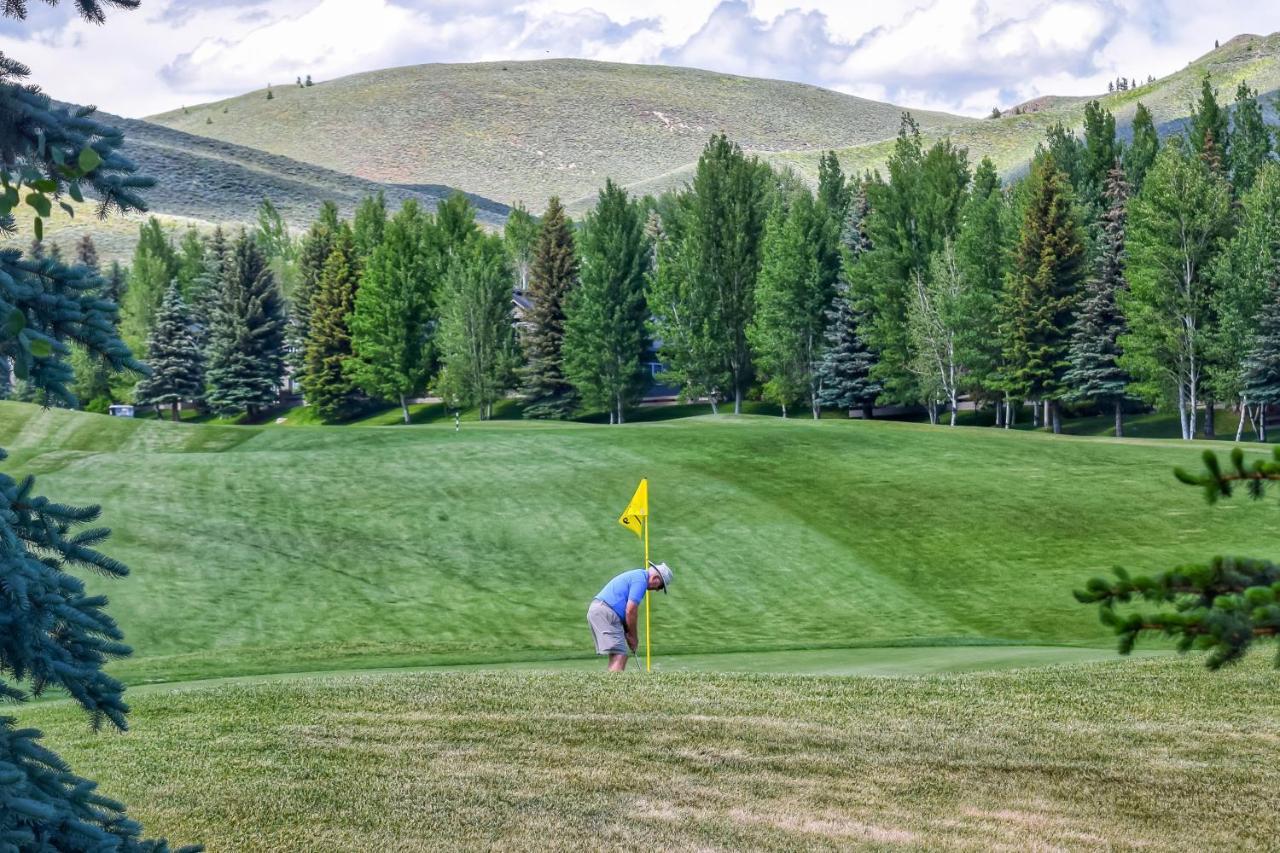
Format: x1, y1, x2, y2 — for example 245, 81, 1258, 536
564, 179, 649, 424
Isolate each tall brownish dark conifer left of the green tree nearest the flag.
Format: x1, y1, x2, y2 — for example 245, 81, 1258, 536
521, 196, 577, 418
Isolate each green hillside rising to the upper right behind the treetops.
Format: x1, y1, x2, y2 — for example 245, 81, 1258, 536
768, 33, 1280, 179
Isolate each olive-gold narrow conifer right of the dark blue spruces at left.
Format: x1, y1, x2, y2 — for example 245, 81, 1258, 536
302, 224, 360, 421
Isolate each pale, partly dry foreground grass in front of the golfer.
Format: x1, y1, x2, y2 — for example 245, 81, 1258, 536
22, 654, 1280, 850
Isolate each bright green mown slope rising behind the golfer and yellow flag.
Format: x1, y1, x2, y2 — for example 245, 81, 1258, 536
0, 403, 1275, 681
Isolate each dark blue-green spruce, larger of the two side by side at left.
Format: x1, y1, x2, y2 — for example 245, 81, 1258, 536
205, 232, 284, 419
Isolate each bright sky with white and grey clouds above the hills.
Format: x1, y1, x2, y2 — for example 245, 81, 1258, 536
0, 0, 1280, 117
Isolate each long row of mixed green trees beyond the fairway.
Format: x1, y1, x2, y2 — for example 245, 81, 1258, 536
55, 77, 1280, 438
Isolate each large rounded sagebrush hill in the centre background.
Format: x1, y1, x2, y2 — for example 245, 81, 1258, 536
150, 59, 972, 210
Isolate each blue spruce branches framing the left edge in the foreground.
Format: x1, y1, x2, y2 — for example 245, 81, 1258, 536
0, 0, 194, 853
